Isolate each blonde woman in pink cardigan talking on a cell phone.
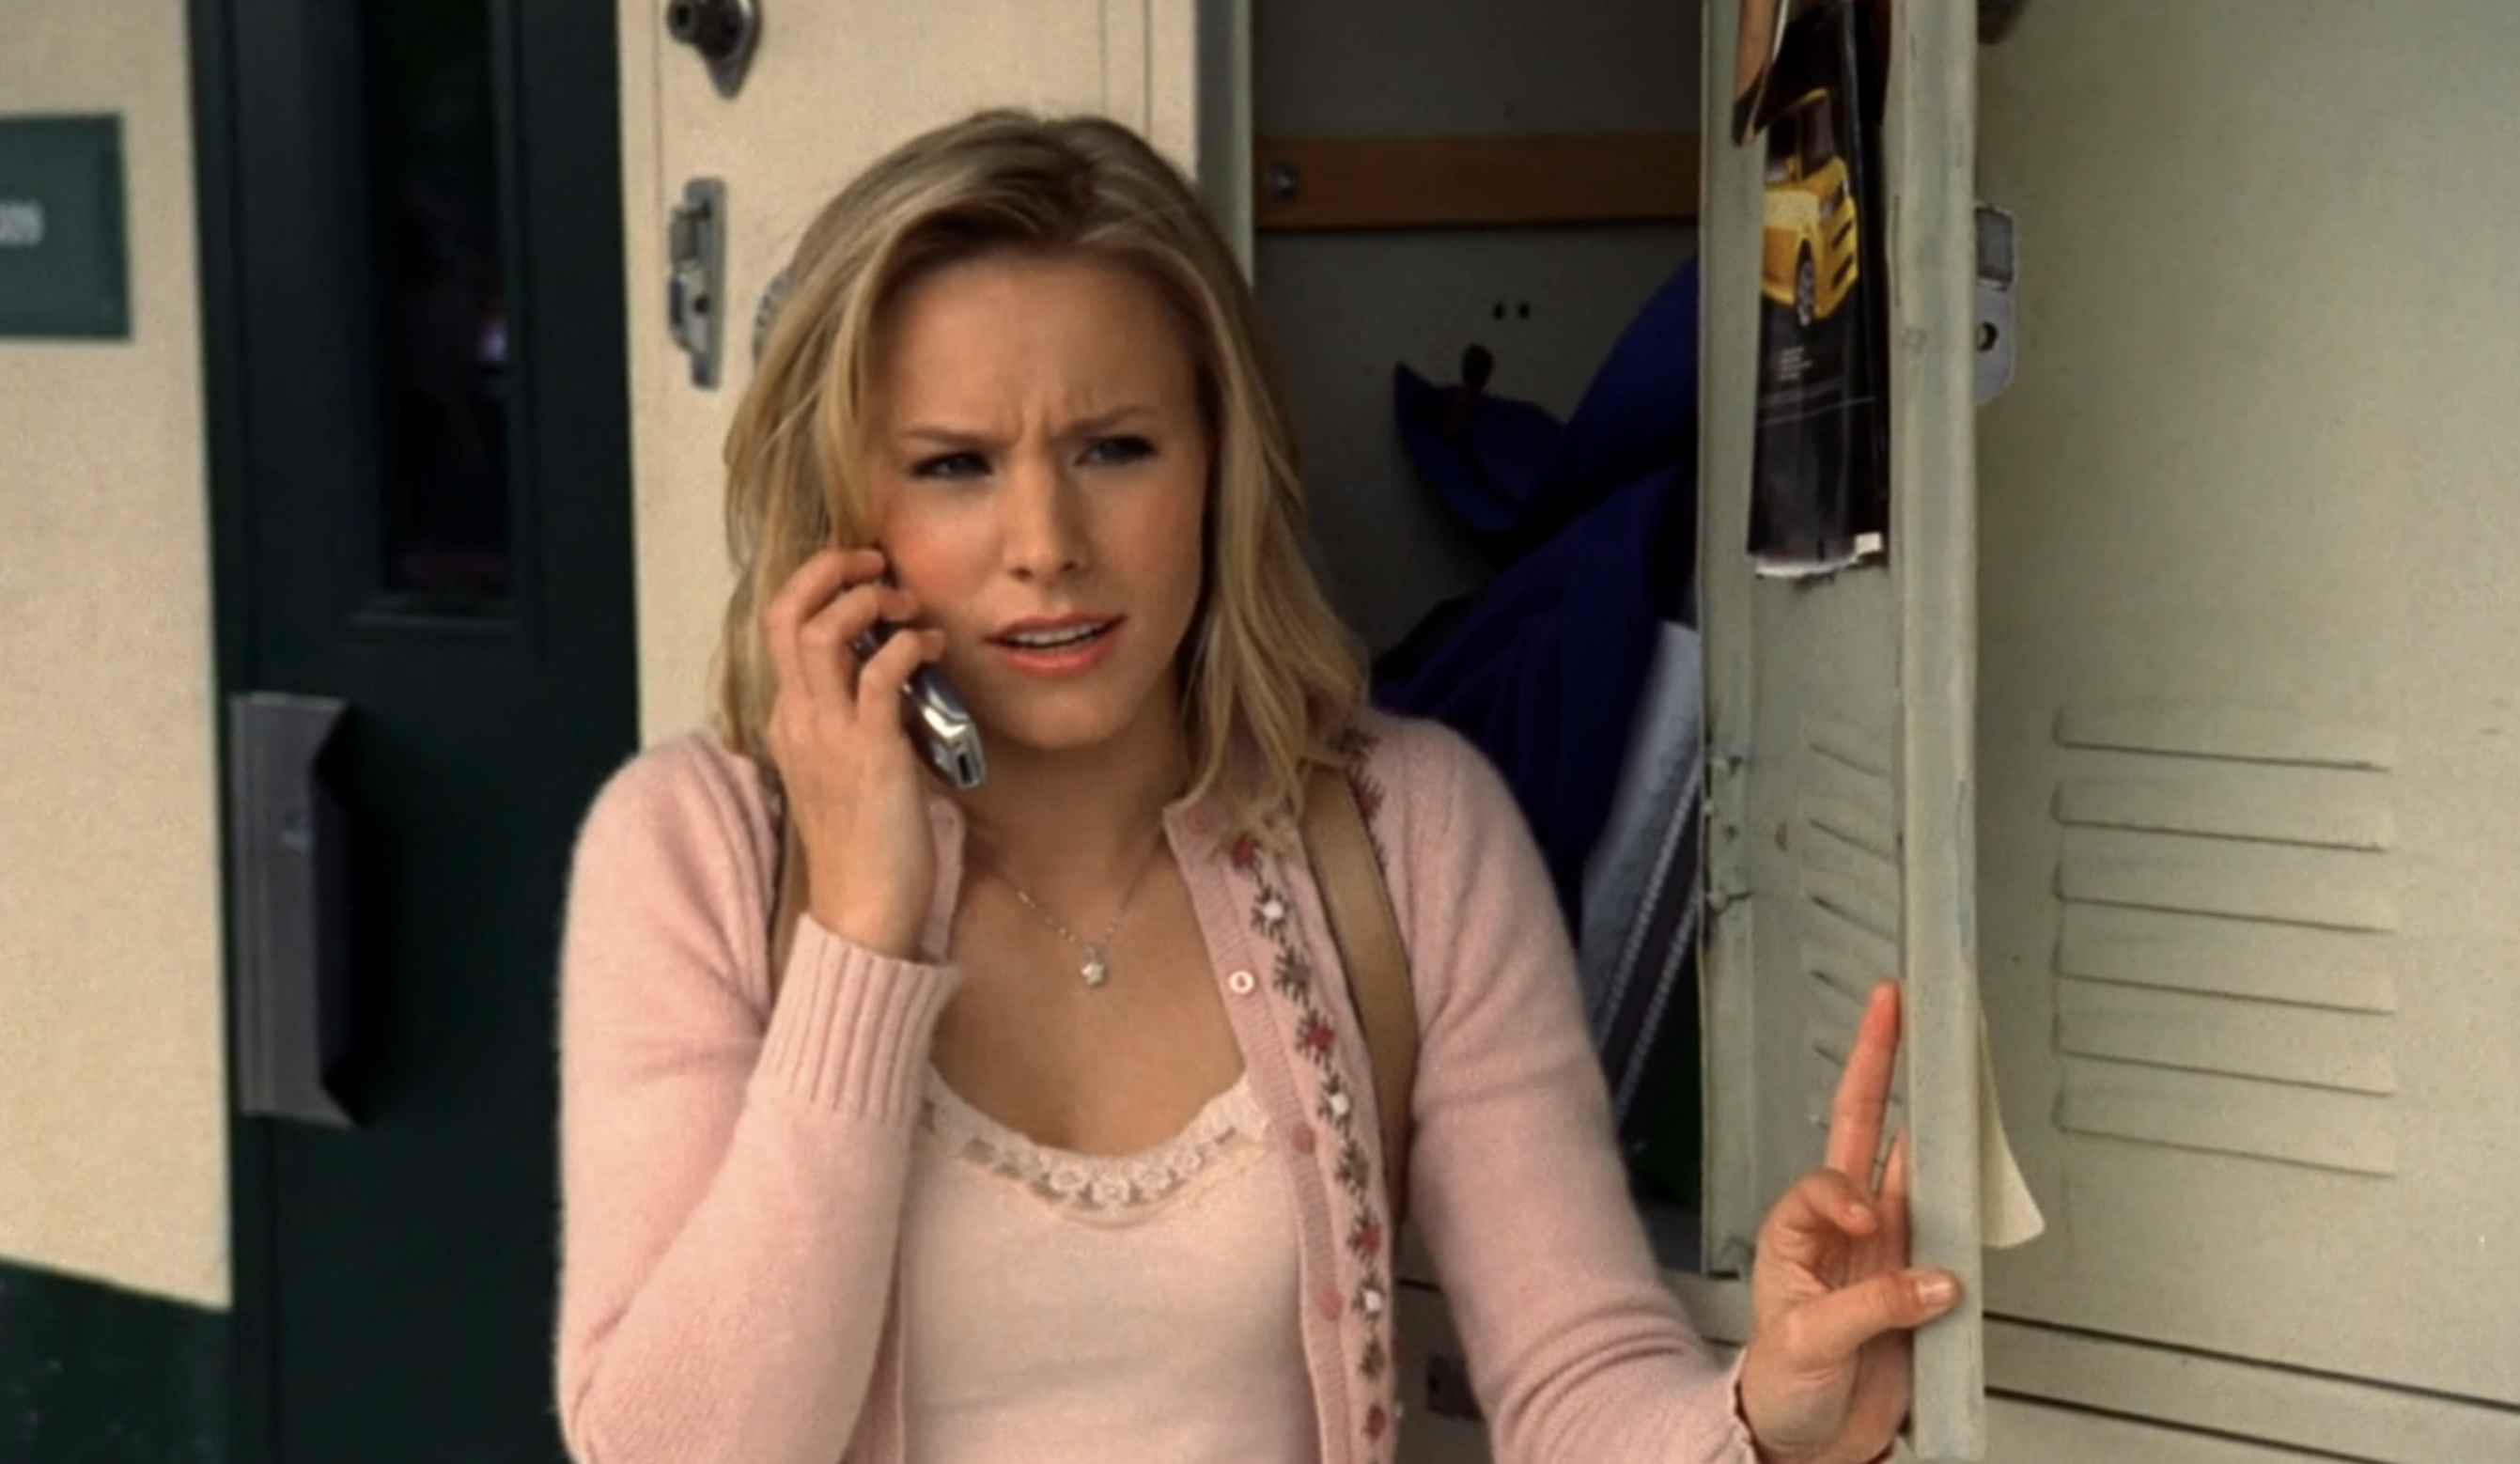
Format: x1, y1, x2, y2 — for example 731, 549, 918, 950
559, 114, 1953, 1464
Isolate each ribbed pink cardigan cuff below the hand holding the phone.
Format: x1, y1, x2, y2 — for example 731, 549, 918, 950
756, 914, 963, 1124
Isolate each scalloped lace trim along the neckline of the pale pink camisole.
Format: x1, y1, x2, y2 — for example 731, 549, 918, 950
925, 1068, 1268, 1217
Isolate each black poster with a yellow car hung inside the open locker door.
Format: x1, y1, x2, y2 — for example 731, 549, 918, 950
1734, 0, 1890, 574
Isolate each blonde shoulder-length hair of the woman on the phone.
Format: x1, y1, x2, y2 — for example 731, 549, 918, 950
713, 111, 1363, 842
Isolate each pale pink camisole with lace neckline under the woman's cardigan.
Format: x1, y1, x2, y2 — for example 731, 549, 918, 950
902, 1071, 1320, 1464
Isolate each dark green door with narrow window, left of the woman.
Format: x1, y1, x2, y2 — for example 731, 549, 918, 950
192, 0, 635, 1464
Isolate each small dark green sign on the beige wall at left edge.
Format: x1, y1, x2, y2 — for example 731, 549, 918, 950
0, 116, 131, 340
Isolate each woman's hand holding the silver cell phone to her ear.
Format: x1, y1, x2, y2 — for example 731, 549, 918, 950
761, 550, 945, 958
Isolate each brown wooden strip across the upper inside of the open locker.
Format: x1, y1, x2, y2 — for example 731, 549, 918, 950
1252, 133, 1699, 232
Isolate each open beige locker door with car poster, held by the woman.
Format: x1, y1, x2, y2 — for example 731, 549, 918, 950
1701, 0, 1985, 1459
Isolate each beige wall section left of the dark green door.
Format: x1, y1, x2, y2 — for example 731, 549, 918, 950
0, 0, 229, 1305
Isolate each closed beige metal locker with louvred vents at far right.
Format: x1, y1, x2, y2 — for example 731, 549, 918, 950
1978, 0, 2520, 1464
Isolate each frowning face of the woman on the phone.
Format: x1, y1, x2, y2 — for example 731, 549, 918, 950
864, 255, 1209, 754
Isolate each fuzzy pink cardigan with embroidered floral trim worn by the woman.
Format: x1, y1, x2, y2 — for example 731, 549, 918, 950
557, 716, 1751, 1464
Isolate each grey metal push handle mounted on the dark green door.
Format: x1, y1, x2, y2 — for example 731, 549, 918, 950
226, 691, 358, 1129
